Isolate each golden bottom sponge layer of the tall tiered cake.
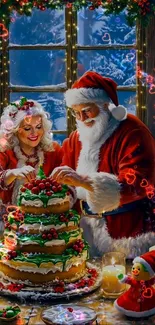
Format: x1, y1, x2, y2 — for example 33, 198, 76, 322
0, 261, 86, 285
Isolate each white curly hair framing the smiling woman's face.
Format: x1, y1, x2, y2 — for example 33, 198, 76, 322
0, 99, 53, 152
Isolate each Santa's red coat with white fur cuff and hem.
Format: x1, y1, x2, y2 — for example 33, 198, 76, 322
62, 114, 155, 257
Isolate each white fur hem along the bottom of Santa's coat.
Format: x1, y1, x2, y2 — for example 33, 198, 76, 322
81, 217, 155, 258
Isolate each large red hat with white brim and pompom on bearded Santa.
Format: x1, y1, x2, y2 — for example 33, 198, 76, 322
65, 71, 127, 121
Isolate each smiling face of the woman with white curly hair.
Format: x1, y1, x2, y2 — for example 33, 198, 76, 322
17, 115, 44, 148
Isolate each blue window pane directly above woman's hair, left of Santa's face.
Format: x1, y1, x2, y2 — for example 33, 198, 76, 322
10, 92, 67, 131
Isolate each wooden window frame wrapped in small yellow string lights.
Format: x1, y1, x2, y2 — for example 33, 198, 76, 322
0, 8, 147, 136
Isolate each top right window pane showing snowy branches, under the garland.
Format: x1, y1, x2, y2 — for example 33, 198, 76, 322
78, 8, 136, 45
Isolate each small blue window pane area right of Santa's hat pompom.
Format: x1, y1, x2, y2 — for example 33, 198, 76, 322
118, 91, 136, 115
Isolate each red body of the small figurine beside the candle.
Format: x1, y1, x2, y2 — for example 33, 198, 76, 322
114, 276, 155, 317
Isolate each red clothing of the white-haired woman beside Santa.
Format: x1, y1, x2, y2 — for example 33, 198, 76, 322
0, 142, 63, 204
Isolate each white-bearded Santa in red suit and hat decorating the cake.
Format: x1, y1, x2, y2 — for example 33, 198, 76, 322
53, 71, 155, 257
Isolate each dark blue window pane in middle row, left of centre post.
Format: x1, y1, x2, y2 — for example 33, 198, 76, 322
9, 50, 66, 87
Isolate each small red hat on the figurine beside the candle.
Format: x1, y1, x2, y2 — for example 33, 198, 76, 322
133, 250, 155, 276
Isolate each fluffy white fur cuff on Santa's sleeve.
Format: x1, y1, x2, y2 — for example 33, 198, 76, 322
86, 172, 121, 213
